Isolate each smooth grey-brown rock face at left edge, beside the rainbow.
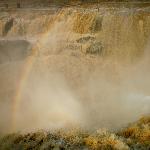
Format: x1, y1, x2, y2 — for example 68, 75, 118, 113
0, 40, 31, 64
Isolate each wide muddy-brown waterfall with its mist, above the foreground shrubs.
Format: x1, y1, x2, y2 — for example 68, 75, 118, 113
0, 7, 150, 132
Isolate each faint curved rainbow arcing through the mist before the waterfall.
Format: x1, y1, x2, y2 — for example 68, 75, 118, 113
10, 10, 63, 132
